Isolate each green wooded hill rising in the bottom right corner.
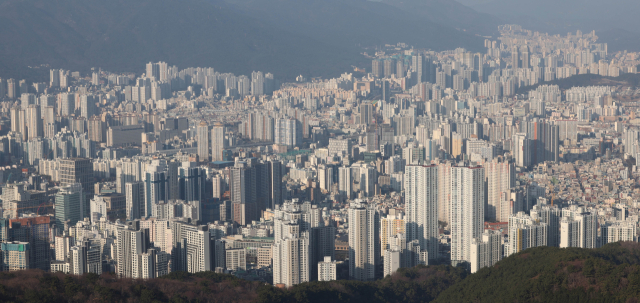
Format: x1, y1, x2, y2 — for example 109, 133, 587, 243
435, 242, 640, 302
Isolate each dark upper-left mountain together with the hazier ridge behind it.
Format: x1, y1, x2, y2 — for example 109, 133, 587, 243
0, 0, 482, 80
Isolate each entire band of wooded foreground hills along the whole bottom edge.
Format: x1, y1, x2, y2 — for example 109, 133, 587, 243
0, 242, 640, 303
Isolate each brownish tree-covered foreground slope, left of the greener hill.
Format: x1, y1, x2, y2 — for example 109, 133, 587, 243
0, 266, 467, 303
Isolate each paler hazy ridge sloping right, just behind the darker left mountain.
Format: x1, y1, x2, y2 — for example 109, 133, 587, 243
221, 0, 483, 51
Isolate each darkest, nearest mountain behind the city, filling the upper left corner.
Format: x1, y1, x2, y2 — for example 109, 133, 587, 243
0, 0, 366, 79
